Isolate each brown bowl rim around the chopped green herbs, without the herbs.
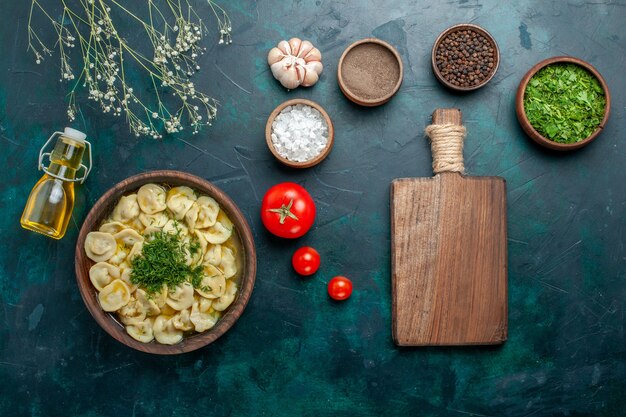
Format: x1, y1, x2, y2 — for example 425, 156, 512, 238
515, 56, 611, 151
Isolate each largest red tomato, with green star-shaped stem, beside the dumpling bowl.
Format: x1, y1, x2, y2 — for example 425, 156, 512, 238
261, 182, 315, 239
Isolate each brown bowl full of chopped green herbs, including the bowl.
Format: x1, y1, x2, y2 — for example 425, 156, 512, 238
515, 56, 611, 151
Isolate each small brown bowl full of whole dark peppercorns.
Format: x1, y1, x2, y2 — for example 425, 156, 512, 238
432, 23, 500, 91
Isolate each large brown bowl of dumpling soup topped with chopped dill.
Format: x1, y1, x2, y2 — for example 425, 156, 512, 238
76, 171, 256, 354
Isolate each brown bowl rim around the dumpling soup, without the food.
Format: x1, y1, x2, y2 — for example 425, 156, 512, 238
75, 171, 256, 355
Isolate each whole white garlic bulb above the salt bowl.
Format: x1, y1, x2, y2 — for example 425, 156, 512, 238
267, 38, 324, 90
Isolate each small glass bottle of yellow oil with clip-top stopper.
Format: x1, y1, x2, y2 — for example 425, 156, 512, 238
21, 127, 91, 239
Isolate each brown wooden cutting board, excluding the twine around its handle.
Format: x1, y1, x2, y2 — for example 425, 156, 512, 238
391, 109, 507, 346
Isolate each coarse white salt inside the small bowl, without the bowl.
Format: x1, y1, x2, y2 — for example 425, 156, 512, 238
272, 104, 328, 162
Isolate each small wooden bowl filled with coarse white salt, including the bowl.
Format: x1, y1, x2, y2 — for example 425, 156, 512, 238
265, 98, 335, 168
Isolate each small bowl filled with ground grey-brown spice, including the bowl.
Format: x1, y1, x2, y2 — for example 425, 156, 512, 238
337, 38, 403, 107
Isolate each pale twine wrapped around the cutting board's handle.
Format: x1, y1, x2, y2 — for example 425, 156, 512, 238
426, 124, 465, 174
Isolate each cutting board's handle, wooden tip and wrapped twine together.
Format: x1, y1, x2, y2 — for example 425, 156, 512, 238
426, 109, 465, 174
